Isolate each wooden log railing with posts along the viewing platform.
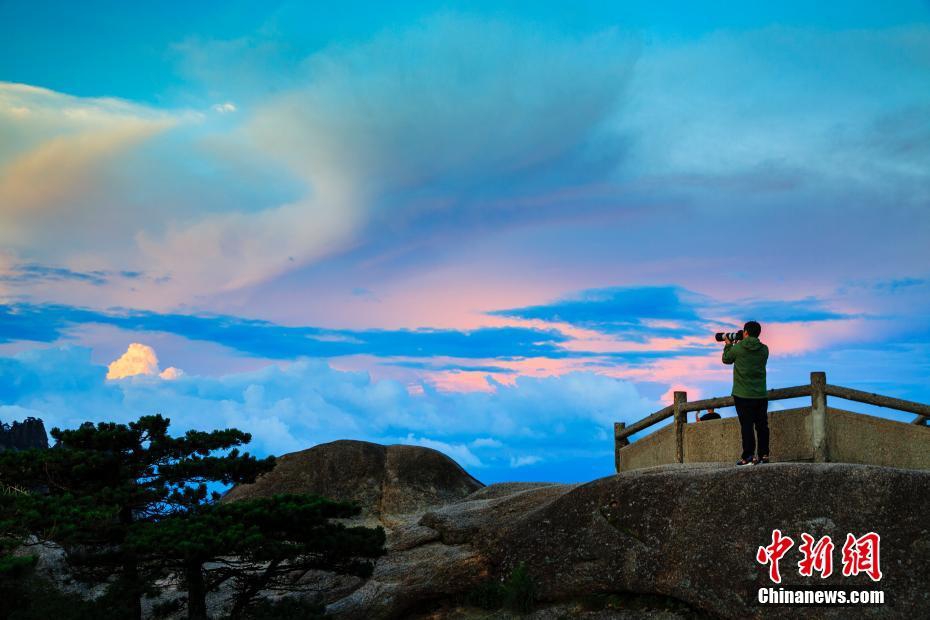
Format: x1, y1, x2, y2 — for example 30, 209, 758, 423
614, 372, 930, 471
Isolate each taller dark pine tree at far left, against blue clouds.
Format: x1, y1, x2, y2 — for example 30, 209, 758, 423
0, 415, 274, 618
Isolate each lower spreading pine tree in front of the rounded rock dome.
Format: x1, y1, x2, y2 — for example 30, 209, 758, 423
129, 495, 384, 618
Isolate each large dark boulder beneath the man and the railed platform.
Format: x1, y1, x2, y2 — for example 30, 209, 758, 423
472, 463, 930, 618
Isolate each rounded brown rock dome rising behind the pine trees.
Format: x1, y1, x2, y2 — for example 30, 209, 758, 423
224, 440, 484, 520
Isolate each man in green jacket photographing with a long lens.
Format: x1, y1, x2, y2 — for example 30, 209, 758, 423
723, 321, 769, 465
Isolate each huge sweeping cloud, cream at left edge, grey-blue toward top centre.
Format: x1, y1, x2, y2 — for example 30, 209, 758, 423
0, 16, 633, 308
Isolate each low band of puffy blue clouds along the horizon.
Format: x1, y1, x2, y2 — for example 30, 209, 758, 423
0, 345, 657, 482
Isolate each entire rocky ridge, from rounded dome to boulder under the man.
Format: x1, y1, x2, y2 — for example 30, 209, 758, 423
229, 442, 930, 618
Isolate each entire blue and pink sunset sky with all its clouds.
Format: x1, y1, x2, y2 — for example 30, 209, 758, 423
0, 0, 930, 482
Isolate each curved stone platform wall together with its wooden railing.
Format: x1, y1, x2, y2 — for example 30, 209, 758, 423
614, 372, 930, 472
